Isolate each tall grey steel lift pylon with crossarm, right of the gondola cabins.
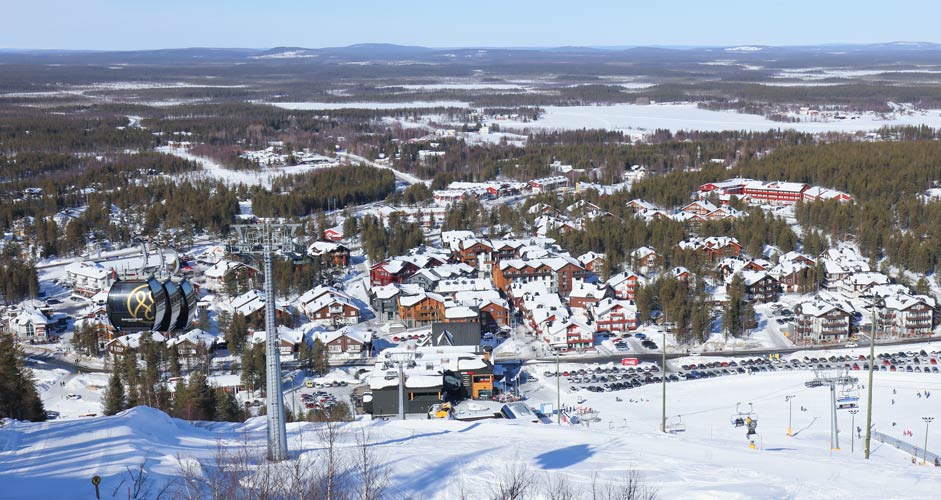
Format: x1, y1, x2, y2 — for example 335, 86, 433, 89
231, 221, 300, 462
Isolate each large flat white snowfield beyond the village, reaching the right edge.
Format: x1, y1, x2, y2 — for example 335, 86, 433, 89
494, 103, 941, 134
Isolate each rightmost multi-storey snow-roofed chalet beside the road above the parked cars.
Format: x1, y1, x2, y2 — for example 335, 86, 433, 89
876, 294, 935, 339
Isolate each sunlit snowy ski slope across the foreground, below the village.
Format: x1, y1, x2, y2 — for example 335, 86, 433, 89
7, 364, 941, 500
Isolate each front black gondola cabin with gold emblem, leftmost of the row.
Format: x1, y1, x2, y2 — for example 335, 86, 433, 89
107, 278, 170, 332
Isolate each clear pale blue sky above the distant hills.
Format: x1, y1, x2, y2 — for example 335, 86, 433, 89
0, 0, 941, 50
